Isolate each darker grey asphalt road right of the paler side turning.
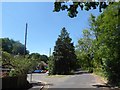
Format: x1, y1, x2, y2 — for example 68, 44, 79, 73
49, 74, 96, 88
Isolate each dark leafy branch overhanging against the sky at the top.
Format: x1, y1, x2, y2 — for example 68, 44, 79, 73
53, 0, 113, 18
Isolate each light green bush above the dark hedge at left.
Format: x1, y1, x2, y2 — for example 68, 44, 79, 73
9, 56, 37, 76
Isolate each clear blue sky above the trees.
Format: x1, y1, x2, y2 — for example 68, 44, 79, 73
2, 2, 100, 55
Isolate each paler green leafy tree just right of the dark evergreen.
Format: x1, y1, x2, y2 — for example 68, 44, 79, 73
76, 30, 93, 72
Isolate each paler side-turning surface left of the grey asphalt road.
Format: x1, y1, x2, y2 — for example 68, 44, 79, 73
27, 73, 69, 90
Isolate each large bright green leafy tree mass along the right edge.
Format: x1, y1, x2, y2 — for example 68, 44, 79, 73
98, 2, 120, 84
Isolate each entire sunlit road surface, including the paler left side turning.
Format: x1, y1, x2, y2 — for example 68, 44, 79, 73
28, 71, 108, 90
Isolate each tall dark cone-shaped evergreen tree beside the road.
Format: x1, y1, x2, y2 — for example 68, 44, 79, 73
51, 27, 76, 74
